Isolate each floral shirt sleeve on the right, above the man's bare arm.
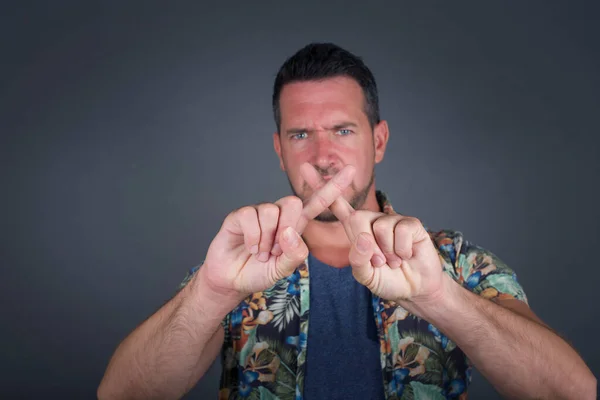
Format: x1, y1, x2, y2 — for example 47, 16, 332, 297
438, 231, 528, 303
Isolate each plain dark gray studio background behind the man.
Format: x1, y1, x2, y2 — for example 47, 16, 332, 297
0, 1, 600, 398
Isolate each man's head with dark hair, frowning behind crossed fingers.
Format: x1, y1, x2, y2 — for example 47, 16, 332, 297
273, 43, 388, 221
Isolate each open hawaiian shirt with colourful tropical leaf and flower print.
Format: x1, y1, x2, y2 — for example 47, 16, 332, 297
179, 191, 527, 400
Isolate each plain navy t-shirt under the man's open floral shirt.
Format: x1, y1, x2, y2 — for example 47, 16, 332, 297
304, 254, 384, 400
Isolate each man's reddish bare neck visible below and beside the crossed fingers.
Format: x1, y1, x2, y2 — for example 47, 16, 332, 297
302, 184, 381, 268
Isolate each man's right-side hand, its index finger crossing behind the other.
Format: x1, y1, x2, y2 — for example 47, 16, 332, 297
301, 163, 443, 301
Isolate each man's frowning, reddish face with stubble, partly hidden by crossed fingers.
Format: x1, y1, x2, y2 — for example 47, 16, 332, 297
273, 77, 387, 221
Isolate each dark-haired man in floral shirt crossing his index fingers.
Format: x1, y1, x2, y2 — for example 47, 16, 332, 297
98, 44, 596, 400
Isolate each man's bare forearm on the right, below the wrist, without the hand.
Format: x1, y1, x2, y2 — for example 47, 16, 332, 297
400, 277, 596, 399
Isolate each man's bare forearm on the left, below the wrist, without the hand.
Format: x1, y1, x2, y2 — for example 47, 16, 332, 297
97, 268, 237, 399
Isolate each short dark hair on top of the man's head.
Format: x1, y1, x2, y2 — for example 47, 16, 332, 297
273, 43, 379, 131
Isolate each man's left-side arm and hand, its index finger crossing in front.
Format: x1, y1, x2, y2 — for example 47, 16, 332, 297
98, 178, 355, 399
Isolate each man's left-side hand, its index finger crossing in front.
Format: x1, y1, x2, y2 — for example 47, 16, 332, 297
200, 166, 355, 300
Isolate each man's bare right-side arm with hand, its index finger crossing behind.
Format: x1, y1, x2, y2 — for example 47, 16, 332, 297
310, 170, 596, 399
